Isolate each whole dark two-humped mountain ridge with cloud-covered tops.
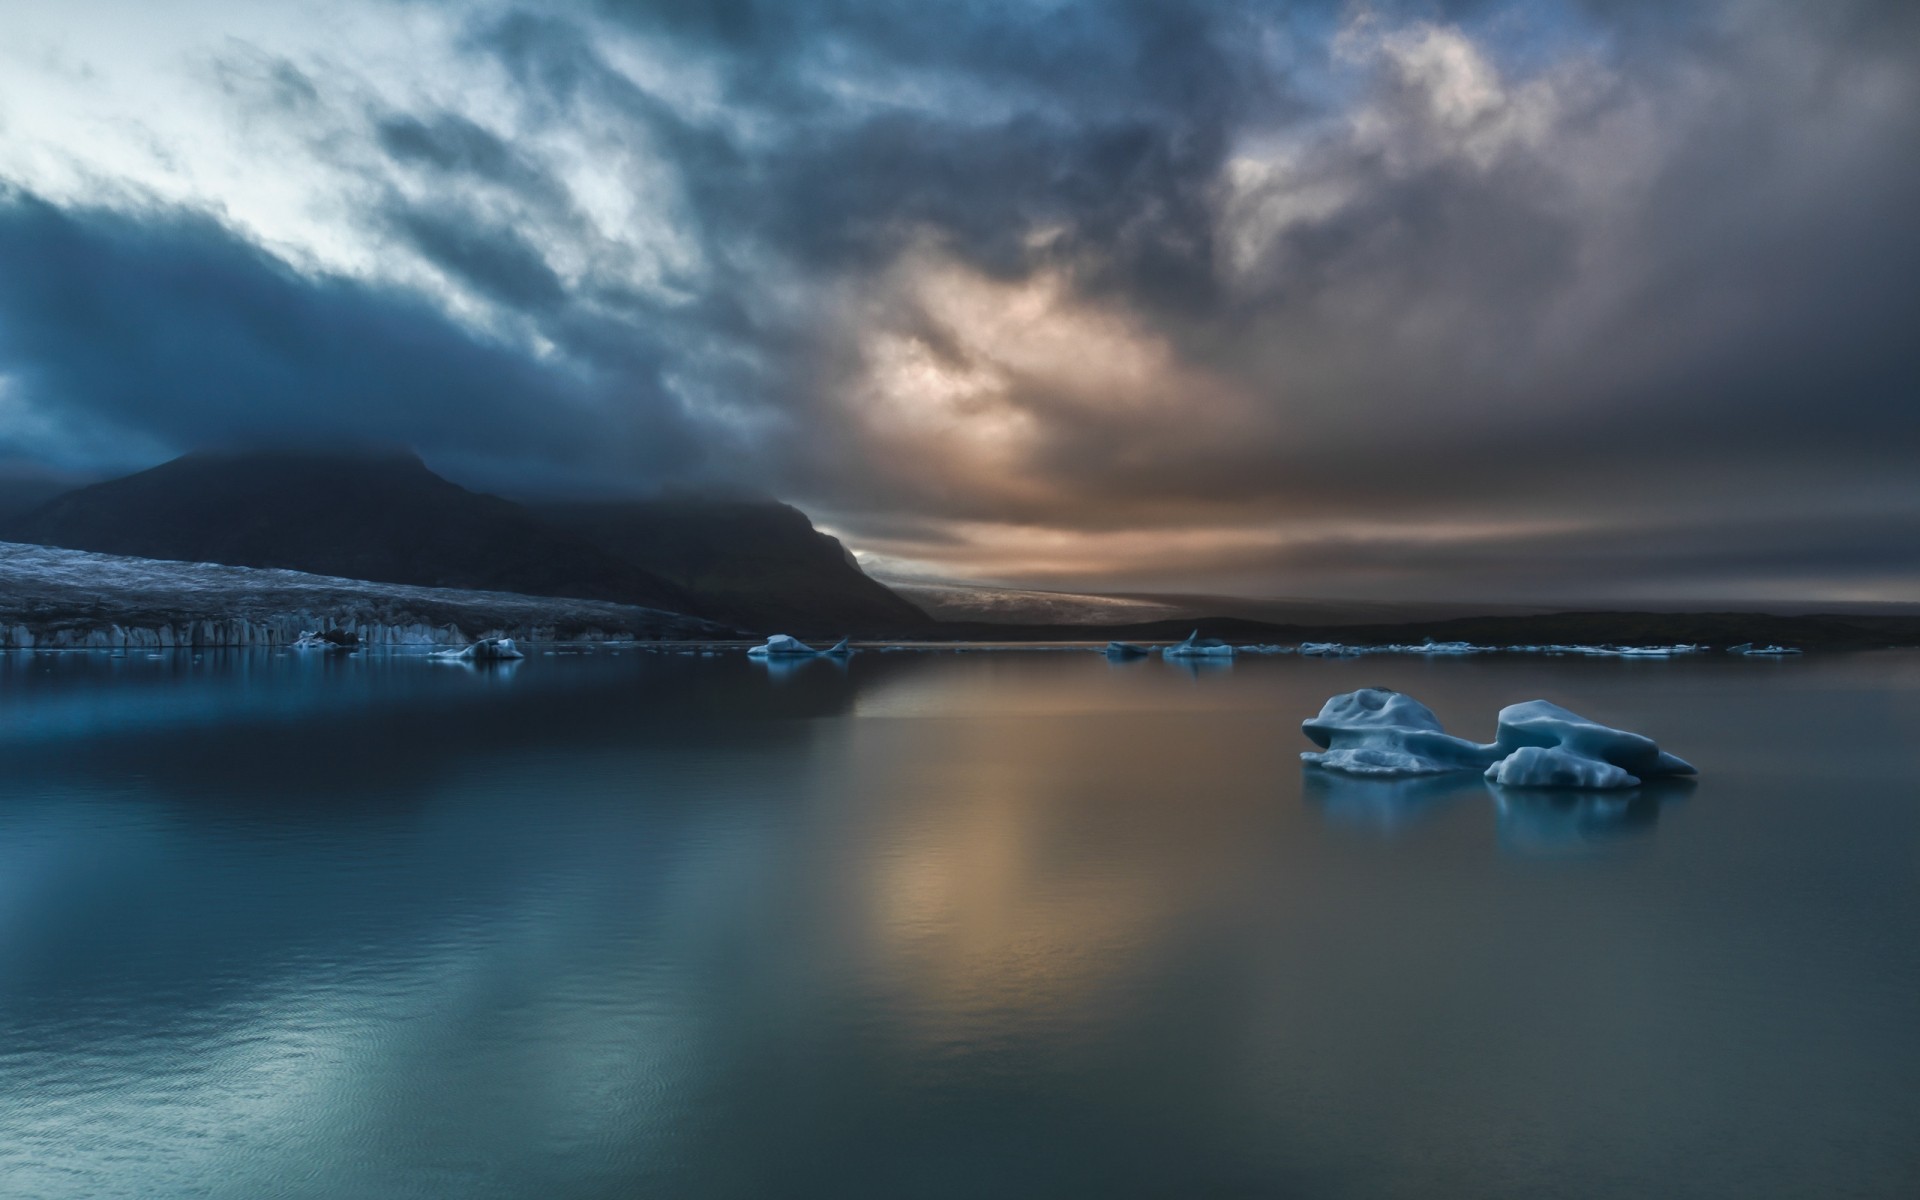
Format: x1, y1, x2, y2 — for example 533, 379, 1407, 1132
0, 445, 927, 636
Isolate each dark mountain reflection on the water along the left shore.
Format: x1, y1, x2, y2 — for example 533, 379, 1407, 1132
0, 649, 948, 818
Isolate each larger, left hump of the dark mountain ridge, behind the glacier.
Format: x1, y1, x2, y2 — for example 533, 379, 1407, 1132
0, 449, 707, 616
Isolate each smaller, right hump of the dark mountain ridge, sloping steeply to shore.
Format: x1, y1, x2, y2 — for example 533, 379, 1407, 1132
534, 495, 931, 636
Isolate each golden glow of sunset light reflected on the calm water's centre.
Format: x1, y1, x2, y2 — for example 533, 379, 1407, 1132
833, 666, 1282, 1043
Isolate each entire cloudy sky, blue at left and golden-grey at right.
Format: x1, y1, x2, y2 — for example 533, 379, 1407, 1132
0, 0, 1920, 605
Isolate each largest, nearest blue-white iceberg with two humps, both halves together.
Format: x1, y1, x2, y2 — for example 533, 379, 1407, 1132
1300, 687, 1693, 789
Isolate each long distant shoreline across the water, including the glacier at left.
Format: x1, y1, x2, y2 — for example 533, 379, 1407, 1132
0, 543, 1920, 649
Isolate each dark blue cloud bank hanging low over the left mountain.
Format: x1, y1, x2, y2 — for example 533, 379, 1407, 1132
0, 192, 689, 480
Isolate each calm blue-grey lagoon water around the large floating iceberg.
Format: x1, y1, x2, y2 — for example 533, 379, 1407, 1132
0, 653, 1920, 1200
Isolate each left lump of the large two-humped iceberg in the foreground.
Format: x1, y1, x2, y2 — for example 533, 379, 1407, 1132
1300, 687, 1500, 778
